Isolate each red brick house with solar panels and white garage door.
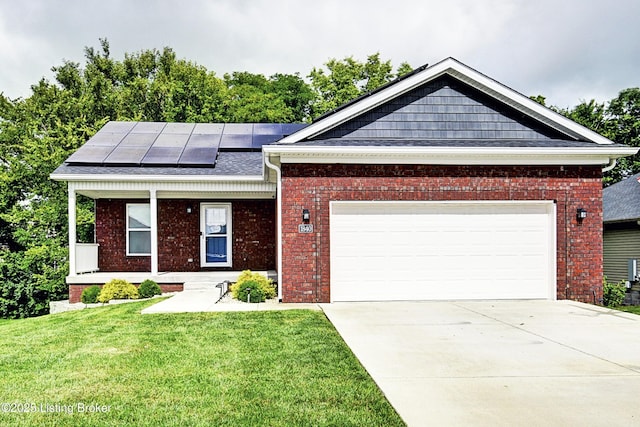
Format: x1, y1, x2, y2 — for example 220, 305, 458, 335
52, 58, 637, 302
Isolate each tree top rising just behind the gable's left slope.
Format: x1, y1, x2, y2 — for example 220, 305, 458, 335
309, 53, 411, 117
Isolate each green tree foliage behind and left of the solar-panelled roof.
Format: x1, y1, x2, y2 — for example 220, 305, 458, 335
0, 40, 410, 317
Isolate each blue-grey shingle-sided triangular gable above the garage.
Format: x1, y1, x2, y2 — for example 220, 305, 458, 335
312, 76, 567, 141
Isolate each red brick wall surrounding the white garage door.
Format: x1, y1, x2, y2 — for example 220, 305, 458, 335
282, 164, 602, 303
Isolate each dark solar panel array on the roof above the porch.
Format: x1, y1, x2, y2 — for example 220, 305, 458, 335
66, 122, 306, 167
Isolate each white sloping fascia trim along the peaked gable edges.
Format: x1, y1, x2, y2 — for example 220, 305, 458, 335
279, 58, 614, 144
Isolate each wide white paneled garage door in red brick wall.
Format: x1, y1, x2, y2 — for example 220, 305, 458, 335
330, 202, 556, 301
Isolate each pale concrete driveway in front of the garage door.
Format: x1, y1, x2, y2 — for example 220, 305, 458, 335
322, 301, 640, 426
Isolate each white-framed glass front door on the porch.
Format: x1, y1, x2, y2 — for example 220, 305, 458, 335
200, 203, 231, 267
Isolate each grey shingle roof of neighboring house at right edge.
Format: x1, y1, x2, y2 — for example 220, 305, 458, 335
602, 173, 640, 223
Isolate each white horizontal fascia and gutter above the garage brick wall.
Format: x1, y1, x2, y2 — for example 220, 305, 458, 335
274, 146, 638, 165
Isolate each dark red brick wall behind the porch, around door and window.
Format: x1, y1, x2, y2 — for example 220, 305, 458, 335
96, 199, 276, 272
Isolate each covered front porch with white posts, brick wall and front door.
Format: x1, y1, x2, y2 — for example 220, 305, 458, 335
60, 176, 276, 301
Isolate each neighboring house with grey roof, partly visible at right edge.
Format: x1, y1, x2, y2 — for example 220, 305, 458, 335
602, 174, 640, 282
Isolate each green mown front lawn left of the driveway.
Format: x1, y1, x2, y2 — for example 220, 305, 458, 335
0, 300, 403, 426
